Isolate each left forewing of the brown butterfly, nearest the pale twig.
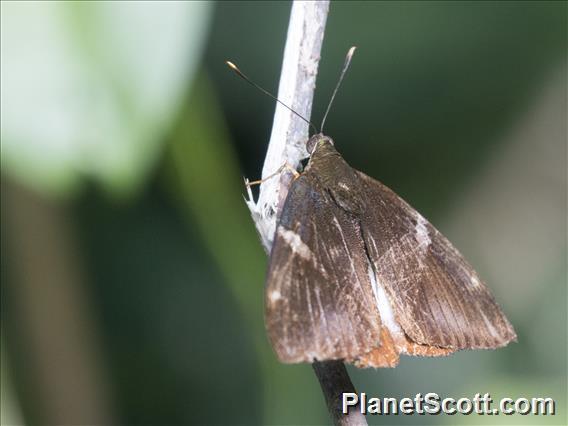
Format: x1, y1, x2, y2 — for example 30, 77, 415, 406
265, 172, 398, 366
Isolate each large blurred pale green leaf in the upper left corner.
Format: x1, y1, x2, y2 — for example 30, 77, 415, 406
1, 2, 211, 196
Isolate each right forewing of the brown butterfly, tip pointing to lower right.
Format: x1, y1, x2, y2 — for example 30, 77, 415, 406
358, 172, 516, 350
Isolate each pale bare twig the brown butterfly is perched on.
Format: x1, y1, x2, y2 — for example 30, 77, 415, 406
243, 0, 367, 426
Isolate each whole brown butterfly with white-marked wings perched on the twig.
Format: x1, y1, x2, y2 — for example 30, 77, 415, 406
226, 48, 516, 367
